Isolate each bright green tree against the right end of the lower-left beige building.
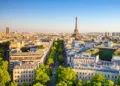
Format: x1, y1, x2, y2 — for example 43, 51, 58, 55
34, 68, 50, 84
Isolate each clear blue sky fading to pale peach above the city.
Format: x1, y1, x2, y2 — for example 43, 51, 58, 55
0, 0, 120, 33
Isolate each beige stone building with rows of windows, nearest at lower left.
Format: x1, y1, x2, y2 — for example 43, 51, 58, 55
13, 62, 39, 86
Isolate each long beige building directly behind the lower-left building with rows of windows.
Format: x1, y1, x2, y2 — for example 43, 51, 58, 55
9, 51, 44, 75
